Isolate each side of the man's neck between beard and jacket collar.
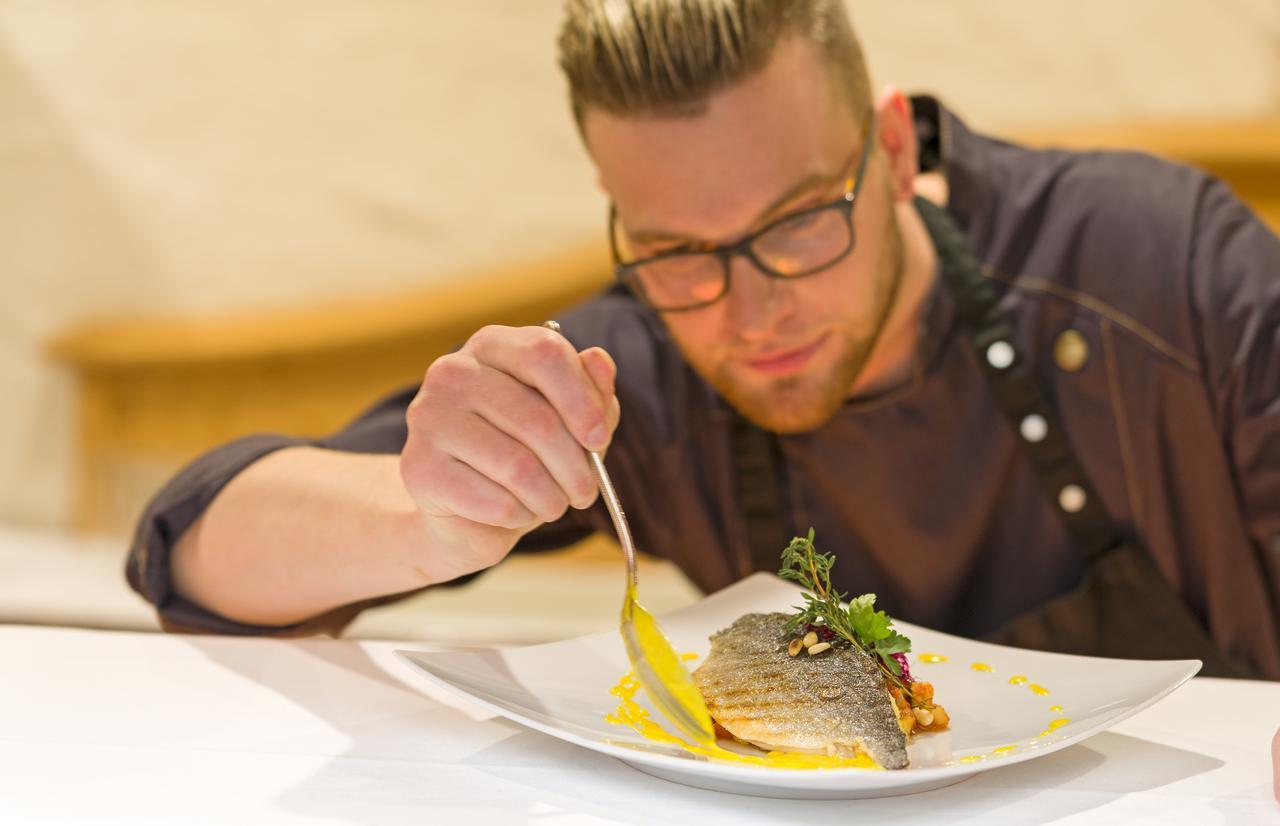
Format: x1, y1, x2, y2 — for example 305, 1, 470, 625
849, 195, 938, 398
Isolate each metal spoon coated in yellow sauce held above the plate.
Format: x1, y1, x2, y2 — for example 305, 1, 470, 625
543, 321, 716, 745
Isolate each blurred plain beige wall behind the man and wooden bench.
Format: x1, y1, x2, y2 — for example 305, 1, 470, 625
0, 0, 1280, 525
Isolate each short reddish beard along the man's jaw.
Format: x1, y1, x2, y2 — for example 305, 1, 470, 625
685, 210, 905, 434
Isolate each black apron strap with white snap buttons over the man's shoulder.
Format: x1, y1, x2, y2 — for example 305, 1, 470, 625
915, 197, 1124, 560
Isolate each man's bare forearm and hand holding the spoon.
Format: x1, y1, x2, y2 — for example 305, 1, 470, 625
162, 322, 618, 626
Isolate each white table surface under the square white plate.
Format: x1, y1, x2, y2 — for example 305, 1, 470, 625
0, 626, 1280, 826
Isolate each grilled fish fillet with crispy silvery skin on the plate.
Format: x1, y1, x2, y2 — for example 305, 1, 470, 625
694, 613, 908, 768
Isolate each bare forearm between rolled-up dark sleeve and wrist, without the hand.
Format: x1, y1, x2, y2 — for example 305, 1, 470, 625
172, 447, 432, 625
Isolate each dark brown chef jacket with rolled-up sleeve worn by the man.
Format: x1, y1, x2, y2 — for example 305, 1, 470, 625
127, 99, 1280, 679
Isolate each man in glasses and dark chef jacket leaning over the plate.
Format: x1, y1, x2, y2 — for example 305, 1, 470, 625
128, 0, 1280, 679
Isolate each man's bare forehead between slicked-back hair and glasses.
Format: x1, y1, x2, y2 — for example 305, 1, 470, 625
584, 40, 859, 239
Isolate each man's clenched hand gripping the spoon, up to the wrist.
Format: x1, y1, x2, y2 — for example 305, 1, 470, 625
401, 327, 618, 581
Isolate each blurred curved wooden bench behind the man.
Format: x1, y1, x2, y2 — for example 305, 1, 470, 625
50, 120, 1280, 533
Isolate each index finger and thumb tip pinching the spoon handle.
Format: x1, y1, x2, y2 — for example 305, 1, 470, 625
467, 327, 613, 451
